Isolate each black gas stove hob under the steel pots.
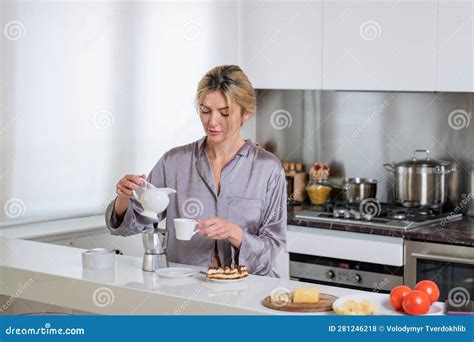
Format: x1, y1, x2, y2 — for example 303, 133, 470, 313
295, 199, 462, 230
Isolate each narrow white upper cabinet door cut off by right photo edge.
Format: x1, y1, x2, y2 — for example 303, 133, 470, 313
436, 0, 474, 92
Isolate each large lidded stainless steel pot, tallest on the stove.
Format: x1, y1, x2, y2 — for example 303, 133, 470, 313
383, 150, 458, 207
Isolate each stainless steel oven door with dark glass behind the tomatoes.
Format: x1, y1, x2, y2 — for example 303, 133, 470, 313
404, 241, 474, 302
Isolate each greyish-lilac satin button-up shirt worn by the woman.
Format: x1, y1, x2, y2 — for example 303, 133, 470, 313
105, 137, 287, 276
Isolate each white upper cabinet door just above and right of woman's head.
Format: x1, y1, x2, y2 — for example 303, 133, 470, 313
240, 0, 322, 89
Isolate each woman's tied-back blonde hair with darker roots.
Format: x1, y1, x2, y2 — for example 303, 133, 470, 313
196, 65, 256, 116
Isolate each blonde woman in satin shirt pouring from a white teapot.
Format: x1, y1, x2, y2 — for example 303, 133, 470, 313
106, 65, 286, 277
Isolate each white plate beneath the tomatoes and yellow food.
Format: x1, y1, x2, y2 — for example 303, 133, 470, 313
332, 292, 443, 315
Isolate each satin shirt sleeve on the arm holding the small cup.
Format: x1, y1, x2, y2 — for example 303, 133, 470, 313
233, 169, 287, 276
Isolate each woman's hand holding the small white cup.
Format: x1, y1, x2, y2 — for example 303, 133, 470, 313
197, 216, 242, 248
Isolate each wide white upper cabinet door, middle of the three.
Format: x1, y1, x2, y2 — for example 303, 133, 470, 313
323, 0, 436, 91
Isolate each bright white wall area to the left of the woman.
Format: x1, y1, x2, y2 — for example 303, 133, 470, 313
0, 1, 255, 222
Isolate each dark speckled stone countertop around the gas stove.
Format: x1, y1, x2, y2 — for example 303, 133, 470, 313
288, 204, 474, 247
